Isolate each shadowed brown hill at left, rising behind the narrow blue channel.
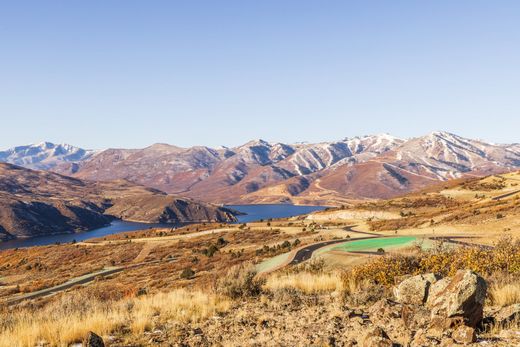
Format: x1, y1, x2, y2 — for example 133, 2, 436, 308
0, 163, 234, 240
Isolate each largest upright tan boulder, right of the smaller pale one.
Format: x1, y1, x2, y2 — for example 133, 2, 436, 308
427, 270, 487, 329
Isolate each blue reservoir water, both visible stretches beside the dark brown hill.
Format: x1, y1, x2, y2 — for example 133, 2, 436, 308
0, 204, 325, 250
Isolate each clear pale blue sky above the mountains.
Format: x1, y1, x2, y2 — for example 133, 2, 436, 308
0, 0, 520, 148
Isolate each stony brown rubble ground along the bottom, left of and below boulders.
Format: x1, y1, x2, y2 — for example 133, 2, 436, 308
136, 271, 520, 347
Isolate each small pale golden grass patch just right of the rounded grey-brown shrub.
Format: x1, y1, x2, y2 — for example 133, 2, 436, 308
264, 272, 343, 294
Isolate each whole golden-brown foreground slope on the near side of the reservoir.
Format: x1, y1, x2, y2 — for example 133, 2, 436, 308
0, 173, 520, 347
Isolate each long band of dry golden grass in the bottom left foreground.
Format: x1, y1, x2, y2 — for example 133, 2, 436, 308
0, 289, 230, 347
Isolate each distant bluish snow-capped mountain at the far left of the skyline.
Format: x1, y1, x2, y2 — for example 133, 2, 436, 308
0, 142, 95, 170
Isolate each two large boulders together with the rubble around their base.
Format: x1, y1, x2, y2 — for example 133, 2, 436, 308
368, 270, 486, 346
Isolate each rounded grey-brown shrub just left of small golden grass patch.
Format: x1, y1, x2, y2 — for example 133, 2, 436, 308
217, 263, 265, 299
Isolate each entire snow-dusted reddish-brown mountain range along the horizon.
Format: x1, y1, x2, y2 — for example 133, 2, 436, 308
0, 132, 520, 204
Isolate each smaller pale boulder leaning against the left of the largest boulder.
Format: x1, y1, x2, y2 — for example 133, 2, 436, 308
394, 273, 437, 305
